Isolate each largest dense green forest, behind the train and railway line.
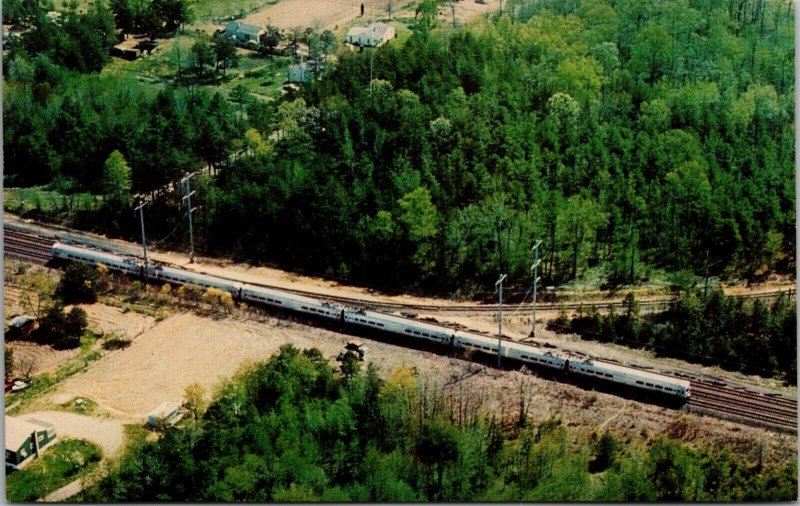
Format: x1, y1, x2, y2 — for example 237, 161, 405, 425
3, 0, 795, 293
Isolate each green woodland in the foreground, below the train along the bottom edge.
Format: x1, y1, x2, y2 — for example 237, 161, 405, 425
80, 345, 797, 502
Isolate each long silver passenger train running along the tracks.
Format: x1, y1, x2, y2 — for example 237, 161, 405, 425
52, 242, 691, 401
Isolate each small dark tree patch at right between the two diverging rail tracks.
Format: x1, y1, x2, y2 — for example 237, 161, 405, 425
548, 289, 797, 385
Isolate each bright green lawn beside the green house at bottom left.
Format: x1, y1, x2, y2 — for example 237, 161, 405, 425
6, 439, 102, 502
